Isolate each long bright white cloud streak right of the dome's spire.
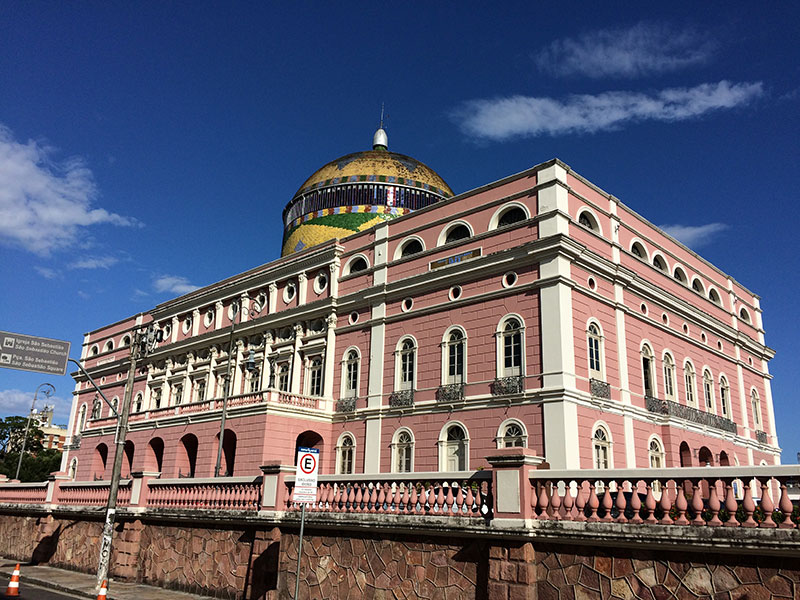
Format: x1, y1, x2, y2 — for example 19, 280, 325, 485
451, 81, 763, 141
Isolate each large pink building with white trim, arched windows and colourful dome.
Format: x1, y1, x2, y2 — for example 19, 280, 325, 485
63, 130, 780, 480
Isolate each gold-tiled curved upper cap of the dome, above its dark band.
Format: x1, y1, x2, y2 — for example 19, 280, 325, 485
295, 150, 453, 198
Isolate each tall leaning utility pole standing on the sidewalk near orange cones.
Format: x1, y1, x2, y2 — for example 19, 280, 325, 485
97, 323, 163, 589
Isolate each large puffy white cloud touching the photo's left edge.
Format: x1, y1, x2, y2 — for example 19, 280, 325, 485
0, 125, 139, 256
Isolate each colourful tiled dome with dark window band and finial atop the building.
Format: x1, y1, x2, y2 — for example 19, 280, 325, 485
281, 128, 453, 256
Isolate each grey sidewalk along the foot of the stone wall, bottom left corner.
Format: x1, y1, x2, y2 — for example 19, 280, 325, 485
0, 558, 216, 600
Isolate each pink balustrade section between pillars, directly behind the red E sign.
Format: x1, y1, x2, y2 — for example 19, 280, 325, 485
285, 471, 491, 518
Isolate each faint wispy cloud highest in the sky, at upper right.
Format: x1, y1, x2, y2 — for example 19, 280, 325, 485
534, 23, 715, 78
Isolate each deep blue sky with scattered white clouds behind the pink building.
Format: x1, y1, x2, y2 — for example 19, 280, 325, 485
0, 2, 800, 462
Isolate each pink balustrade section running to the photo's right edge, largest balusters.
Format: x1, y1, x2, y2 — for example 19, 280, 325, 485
530, 465, 800, 529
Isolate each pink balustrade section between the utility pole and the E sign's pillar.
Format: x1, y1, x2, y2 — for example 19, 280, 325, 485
147, 477, 261, 510
